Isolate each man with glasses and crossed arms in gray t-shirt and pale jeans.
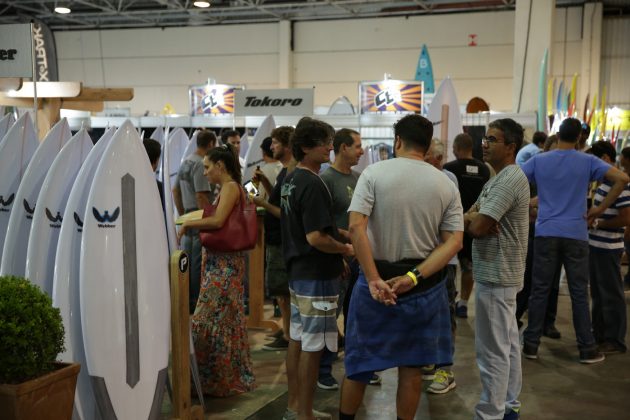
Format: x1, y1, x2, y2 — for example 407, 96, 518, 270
464, 118, 529, 419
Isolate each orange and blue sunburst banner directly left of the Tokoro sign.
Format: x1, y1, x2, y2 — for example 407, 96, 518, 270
188, 85, 243, 116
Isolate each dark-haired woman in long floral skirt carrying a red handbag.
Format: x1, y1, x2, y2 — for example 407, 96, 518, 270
178, 144, 256, 397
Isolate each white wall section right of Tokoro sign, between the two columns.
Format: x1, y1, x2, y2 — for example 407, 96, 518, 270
294, 12, 514, 109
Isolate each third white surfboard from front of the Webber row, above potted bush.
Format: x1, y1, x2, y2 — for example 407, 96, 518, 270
25, 129, 92, 296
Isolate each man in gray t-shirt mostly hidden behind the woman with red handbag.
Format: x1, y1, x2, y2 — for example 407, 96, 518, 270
173, 130, 217, 313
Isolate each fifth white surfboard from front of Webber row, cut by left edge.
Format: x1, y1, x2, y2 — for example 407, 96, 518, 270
0, 113, 39, 257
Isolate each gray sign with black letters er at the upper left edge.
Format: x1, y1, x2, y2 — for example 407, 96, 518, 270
0, 23, 33, 77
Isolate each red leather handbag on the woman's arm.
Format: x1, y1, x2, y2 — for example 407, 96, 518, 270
199, 187, 258, 252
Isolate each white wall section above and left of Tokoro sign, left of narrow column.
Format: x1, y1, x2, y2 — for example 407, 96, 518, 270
55, 24, 278, 114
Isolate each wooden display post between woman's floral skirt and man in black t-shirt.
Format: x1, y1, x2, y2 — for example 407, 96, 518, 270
247, 212, 280, 332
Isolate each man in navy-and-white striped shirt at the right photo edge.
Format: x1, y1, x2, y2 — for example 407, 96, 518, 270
588, 141, 630, 354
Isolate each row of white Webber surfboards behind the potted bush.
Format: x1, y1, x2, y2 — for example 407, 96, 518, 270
0, 113, 189, 419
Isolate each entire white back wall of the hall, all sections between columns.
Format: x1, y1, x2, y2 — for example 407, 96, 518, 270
55, 7, 596, 114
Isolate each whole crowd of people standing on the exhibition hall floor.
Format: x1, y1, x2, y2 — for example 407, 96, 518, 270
154, 111, 630, 420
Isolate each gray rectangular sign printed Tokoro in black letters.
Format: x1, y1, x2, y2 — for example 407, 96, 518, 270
234, 88, 314, 117
